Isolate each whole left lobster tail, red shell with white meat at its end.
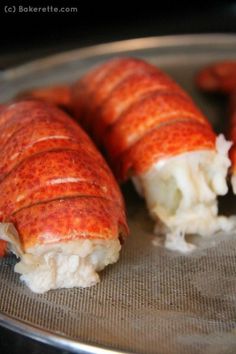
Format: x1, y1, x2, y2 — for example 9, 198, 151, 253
0, 100, 128, 293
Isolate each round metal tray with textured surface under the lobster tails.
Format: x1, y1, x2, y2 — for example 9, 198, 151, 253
0, 34, 236, 354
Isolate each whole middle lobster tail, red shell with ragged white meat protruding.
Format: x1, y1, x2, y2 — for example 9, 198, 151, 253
71, 58, 233, 251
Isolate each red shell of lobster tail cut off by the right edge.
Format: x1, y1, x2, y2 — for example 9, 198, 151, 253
196, 60, 236, 194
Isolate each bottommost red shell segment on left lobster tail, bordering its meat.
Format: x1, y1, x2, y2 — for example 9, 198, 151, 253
9, 196, 126, 248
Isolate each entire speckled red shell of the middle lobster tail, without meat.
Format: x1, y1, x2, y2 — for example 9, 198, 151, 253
72, 58, 218, 180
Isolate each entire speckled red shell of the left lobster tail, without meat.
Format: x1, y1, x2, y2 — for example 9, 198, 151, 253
0, 100, 128, 254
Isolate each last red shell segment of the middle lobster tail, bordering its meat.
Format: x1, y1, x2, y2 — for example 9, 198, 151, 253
112, 121, 215, 180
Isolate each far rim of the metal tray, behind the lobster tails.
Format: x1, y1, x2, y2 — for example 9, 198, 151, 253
0, 33, 236, 81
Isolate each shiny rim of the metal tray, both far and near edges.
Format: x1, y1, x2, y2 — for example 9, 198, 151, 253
0, 33, 236, 354
